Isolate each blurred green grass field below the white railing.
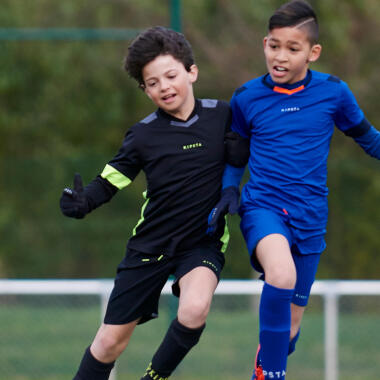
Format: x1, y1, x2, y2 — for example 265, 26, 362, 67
0, 296, 380, 380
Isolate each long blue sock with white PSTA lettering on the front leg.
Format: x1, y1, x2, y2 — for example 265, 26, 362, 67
260, 283, 294, 380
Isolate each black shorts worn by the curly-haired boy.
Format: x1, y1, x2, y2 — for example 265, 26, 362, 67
104, 246, 224, 325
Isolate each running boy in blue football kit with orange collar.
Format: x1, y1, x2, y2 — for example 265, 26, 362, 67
209, 0, 380, 380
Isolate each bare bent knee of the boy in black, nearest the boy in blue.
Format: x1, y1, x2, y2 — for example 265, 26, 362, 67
178, 299, 210, 328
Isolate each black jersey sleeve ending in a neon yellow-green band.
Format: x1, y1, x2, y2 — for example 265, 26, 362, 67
100, 128, 141, 190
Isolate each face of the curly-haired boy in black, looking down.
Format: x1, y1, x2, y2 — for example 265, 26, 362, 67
142, 54, 198, 120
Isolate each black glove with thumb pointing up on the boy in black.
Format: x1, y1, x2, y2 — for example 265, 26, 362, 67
59, 173, 90, 219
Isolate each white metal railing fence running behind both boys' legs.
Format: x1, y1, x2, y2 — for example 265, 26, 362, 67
0, 279, 380, 380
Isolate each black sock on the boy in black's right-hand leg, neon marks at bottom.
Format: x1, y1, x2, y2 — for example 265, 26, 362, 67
142, 318, 206, 380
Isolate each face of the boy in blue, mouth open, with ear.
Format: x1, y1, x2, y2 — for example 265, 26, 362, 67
264, 27, 322, 84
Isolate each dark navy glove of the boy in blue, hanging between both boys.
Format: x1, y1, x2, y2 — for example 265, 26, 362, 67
206, 186, 240, 235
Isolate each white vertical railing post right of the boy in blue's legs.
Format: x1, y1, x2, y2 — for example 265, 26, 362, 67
324, 284, 339, 380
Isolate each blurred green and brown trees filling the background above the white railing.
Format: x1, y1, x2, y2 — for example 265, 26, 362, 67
0, 0, 380, 278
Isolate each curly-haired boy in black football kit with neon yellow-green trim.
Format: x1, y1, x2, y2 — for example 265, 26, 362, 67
60, 27, 232, 380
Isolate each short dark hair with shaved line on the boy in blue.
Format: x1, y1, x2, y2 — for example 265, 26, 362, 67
268, 0, 319, 45
